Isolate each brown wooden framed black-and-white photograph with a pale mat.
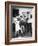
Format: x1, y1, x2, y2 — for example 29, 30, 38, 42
5, 1, 37, 44
